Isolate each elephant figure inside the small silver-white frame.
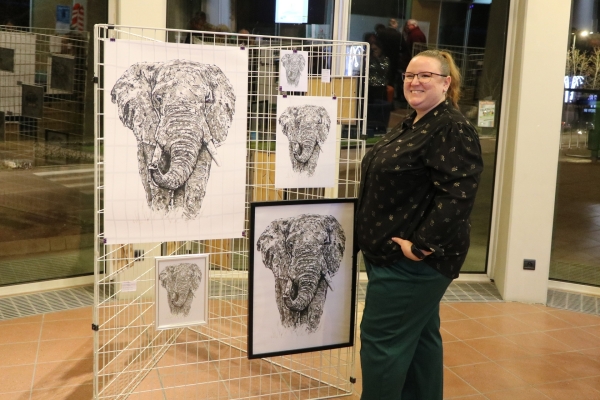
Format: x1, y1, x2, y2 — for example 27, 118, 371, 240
158, 263, 202, 317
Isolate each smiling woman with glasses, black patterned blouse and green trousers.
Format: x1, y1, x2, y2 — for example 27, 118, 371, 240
356, 50, 483, 400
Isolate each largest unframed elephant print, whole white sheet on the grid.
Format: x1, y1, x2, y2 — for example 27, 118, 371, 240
103, 40, 248, 243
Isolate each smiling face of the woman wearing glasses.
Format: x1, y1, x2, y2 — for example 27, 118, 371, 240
404, 56, 451, 117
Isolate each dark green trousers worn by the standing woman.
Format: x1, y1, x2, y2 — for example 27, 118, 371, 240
360, 259, 452, 400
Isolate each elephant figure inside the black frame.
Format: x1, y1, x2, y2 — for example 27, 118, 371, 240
257, 214, 346, 332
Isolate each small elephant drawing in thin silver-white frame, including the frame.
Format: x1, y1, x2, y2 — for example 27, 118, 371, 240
155, 254, 208, 329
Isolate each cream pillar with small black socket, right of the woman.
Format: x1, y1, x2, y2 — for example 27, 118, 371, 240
490, 0, 571, 303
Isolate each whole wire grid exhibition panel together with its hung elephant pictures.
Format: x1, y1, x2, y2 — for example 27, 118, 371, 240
93, 25, 368, 399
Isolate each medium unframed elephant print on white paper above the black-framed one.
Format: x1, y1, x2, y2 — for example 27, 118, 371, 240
275, 96, 339, 189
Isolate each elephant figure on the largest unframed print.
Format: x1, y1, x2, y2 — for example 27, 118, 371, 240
111, 60, 235, 219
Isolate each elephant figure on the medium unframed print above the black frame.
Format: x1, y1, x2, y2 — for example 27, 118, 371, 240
279, 104, 331, 176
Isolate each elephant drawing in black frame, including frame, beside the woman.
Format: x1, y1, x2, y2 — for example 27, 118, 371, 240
248, 199, 357, 358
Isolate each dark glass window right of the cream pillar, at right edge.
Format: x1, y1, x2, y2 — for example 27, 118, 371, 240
550, 0, 600, 286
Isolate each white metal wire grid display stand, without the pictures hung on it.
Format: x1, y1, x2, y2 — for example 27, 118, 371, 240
93, 25, 368, 400
